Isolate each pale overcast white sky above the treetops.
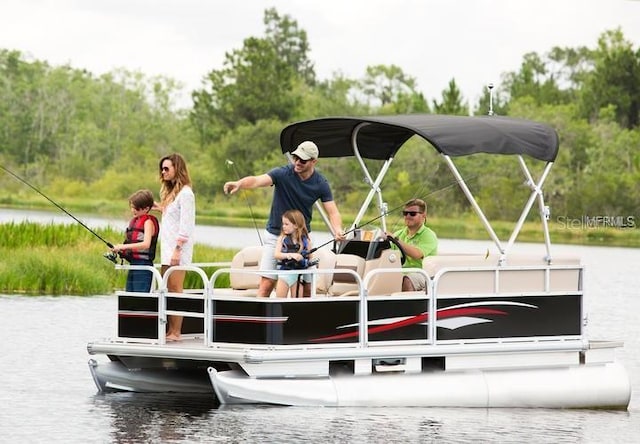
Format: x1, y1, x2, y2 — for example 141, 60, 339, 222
0, 0, 640, 108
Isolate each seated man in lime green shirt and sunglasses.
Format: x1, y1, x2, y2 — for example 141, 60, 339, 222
392, 199, 438, 291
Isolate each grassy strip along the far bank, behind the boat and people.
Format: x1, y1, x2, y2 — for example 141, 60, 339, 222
0, 200, 640, 246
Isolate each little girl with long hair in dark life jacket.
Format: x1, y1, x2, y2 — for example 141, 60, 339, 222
273, 210, 312, 298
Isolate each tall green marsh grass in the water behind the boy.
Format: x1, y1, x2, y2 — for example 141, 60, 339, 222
0, 221, 234, 296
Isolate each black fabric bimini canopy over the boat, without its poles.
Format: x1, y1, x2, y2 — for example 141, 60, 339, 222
280, 114, 558, 162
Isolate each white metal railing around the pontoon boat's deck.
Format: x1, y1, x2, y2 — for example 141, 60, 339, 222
111, 263, 585, 349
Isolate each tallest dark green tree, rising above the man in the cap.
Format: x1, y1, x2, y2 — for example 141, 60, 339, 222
191, 8, 316, 145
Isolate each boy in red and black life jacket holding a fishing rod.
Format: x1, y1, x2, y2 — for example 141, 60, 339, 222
111, 190, 160, 292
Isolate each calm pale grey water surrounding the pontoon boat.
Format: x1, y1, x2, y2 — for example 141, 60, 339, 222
0, 211, 640, 443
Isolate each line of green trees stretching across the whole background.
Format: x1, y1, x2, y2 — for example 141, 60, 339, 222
0, 8, 640, 225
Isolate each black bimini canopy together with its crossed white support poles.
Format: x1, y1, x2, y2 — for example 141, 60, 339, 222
280, 114, 559, 263
